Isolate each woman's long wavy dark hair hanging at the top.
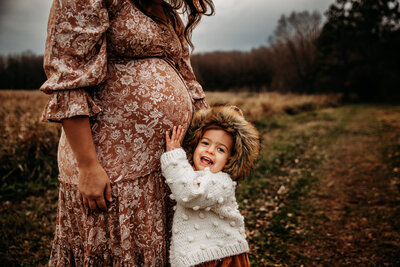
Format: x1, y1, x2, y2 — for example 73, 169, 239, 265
132, 0, 214, 49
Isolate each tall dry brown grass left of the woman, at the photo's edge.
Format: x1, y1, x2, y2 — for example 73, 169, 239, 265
0, 90, 60, 199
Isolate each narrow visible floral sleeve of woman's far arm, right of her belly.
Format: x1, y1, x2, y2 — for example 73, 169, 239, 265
177, 22, 209, 111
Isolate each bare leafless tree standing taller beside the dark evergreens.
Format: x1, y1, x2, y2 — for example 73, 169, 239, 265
269, 11, 321, 92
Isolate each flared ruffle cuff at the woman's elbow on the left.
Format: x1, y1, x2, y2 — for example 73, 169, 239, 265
41, 89, 101, 122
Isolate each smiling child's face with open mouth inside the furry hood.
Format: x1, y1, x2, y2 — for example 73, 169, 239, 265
193, 129, 233, 173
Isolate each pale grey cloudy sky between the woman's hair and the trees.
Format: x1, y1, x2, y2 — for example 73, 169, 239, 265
193, 0, 334, 52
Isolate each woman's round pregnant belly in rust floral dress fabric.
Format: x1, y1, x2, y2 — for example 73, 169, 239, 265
59, 58, 192, 183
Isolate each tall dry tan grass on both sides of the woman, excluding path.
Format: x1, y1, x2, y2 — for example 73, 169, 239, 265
0, 90, 341, 189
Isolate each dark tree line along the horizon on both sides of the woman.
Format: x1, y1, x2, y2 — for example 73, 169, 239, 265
0, 0, 400, 100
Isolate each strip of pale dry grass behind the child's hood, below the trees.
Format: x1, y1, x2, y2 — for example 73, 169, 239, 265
207, 92, 342, 120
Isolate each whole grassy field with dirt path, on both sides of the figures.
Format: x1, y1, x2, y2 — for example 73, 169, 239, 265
0, 91, 400, 266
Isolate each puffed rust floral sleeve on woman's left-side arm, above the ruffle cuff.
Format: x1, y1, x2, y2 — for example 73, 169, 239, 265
40, 0, 109, 94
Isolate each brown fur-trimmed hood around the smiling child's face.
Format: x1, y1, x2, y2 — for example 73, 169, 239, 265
183, 106, 260, 180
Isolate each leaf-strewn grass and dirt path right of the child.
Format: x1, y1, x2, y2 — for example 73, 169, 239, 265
239, 105, 400, 266
